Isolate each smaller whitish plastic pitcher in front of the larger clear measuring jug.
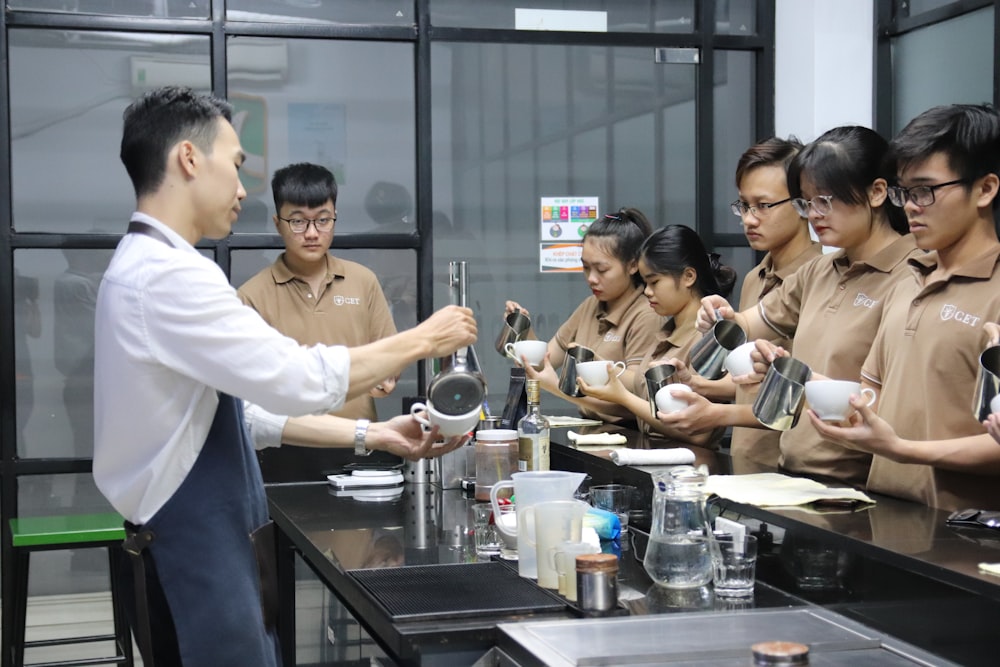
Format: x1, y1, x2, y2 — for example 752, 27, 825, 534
524, 500, 590, 588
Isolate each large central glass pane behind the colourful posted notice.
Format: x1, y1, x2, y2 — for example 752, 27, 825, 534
431, 43, 700, 412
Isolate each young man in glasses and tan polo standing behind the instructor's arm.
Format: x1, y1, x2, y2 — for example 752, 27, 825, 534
238, 162, 396, 420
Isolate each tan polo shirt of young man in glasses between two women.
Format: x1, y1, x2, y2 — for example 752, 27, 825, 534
730, 242, 823, 468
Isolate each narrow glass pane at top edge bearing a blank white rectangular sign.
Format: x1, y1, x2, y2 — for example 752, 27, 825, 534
430, 0, 694, 33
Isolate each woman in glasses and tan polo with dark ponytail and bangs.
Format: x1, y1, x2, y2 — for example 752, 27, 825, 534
698, 126, 920, 486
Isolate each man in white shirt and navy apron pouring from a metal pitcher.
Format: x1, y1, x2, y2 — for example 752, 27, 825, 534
94, 87, 476, 667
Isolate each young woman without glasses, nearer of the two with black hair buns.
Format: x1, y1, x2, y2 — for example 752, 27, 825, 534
570, 225, 736, 446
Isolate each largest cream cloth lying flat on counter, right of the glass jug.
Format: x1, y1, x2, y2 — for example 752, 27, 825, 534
705, 472, 875, 507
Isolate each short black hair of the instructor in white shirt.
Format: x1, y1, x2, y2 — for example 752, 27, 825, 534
119, 86, 233, 197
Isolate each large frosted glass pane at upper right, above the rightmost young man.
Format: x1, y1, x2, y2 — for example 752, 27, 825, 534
892, 7, 995, 133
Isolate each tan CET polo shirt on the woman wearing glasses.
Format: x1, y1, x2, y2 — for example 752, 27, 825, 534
758, 234, 923, 486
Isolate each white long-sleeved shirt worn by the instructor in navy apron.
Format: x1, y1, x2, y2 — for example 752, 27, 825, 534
94, 213, 350, 524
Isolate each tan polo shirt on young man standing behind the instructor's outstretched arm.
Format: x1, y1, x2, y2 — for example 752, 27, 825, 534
239, 253, 396, 420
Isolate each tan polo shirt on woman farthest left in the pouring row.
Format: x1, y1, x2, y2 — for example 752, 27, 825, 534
555, 286, 663, 424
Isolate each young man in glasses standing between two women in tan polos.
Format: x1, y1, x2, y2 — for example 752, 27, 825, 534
666, 137, 823, 472
